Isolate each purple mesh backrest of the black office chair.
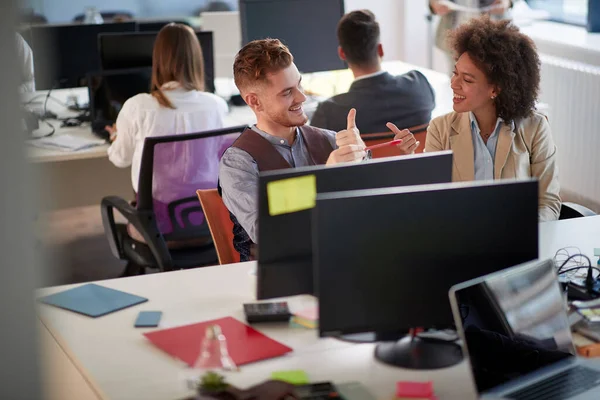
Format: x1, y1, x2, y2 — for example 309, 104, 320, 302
137, 126, 246, 241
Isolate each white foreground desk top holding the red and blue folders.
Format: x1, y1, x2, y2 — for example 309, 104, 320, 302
37, 216, 600, 400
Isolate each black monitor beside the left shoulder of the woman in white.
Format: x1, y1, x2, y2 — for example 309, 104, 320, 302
88, 67, 152, 129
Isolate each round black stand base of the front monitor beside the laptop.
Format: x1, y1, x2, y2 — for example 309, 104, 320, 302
375, 335, 463, 369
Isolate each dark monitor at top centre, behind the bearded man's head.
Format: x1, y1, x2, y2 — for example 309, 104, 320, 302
240, 0, 345, 72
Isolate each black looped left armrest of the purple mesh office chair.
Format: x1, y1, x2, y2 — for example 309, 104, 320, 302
100, 196, 173, 271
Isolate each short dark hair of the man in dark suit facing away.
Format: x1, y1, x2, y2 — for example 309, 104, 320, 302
337, 10, 379, 66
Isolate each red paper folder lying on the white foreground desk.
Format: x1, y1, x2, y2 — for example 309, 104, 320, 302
144, 317, 292, 367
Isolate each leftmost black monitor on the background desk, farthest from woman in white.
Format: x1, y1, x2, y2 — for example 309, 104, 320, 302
23, 22, 136, 90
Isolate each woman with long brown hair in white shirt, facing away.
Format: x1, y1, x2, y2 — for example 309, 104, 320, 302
106, 23, 227, 193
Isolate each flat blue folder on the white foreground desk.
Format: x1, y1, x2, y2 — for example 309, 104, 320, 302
38, 283, 148, 318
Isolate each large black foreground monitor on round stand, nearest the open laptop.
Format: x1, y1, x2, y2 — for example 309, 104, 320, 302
312, 180, 538, 368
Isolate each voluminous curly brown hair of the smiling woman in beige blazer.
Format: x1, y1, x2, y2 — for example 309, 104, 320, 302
449, 16, 540, 121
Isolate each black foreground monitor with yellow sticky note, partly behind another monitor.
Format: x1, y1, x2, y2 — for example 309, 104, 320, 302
256, 151, 452, 299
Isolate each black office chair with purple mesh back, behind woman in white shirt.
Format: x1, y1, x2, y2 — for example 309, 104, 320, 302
101, 126, 245, 276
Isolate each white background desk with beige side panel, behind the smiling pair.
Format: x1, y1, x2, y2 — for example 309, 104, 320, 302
27, 61, 452, 210
